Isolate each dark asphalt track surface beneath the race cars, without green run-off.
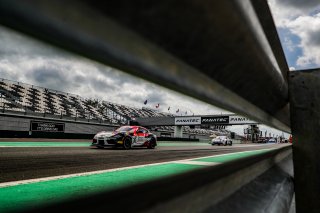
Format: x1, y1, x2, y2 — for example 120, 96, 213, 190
0, 142, 282, 183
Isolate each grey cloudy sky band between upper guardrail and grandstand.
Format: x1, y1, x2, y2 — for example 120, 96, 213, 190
0, 24, 225, 119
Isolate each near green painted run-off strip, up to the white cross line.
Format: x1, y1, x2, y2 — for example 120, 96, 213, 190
0, 163, 200, 212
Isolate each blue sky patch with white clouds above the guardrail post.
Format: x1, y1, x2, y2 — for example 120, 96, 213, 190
269, 0, 320, 70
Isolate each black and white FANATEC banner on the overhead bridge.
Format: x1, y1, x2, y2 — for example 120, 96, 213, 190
175, 115, 257, 126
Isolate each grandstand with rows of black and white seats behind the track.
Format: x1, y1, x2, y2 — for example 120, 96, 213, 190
0, 79, 229, 135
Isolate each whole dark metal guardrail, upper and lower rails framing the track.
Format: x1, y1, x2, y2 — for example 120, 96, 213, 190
0, 0, 300, 212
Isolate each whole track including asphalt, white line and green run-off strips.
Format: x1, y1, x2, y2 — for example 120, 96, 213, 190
0, 141, 292, 212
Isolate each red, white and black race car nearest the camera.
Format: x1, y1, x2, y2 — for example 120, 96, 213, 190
91, 126, 157, 149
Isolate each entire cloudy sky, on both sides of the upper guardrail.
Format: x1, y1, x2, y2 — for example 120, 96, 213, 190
0, 0, 320, 134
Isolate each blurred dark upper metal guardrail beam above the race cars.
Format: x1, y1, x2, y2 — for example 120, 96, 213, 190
0, 0, 290, 132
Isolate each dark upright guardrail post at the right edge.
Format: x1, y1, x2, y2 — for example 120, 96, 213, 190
289, 69, 320, 212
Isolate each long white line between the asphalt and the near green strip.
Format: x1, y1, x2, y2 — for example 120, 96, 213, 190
0, 148, 276, 188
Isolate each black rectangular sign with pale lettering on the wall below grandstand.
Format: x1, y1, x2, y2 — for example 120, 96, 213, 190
30, 121, 64, 132
